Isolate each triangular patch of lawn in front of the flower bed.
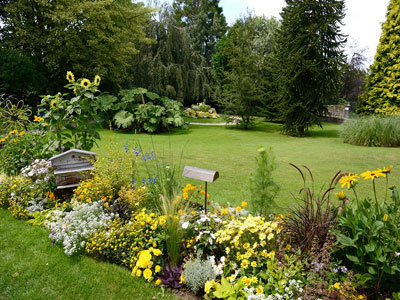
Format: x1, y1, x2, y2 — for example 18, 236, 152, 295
0, 209, 177, 300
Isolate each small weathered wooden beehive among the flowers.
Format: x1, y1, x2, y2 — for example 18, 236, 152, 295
50, 149, 97, 189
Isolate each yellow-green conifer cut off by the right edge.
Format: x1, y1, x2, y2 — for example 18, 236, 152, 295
357, 0, 400, 115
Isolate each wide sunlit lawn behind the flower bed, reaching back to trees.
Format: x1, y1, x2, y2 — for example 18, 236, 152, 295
93, 123, 400, 207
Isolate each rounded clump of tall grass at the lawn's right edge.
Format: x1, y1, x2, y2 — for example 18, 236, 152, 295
341, 116, 400, 147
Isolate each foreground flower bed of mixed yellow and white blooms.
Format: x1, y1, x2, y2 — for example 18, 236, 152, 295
0, 152, 400, 299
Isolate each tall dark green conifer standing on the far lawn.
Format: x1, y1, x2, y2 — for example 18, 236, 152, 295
273, 0, 345, 136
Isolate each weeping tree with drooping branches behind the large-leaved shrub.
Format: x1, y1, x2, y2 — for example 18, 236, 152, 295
130, 4, 213, 105
